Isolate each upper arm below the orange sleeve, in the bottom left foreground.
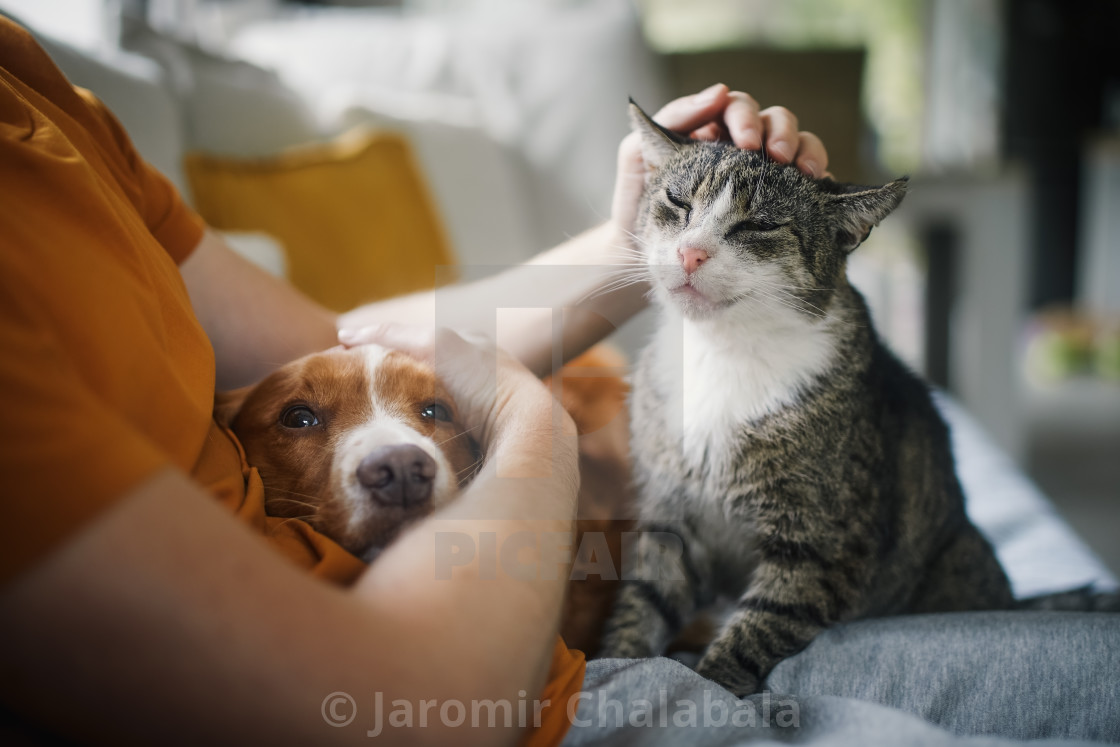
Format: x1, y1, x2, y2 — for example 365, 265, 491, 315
0, 470, 573, 744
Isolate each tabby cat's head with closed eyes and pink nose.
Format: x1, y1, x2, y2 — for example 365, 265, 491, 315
631, 102, 906, 319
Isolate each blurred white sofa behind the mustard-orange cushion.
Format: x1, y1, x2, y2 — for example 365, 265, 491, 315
28, 0, 665, 273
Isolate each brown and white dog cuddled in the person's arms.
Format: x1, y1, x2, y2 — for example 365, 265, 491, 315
215, 345, 631, 654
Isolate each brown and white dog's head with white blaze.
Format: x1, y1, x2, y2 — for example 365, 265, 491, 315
231, 345, 480, 559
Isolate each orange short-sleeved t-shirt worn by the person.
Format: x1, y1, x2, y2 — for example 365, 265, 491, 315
0, 17, 584, 744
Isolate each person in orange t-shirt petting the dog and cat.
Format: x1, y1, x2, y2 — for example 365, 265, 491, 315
0, 17, 827, 744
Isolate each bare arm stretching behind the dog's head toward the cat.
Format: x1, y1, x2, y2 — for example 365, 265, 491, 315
181, 223, 645, 389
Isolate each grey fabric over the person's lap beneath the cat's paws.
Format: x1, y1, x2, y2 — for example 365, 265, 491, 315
564, 613, 1120, 747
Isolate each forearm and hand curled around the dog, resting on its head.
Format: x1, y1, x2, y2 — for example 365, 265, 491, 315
338, 327, 579, 697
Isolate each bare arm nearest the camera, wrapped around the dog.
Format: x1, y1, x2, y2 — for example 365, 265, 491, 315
0, 331, 578, 744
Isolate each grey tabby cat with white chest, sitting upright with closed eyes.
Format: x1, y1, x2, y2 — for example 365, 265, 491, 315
601, 105, 1012, 695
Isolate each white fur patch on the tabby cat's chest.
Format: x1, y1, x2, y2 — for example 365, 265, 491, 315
655, 309, 833, 473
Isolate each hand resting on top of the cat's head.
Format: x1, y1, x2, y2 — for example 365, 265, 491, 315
610, 83, 829, 240
